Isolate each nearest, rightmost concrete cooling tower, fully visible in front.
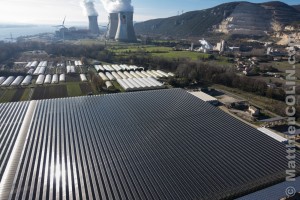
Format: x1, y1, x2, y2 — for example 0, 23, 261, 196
115, 12, 136, 42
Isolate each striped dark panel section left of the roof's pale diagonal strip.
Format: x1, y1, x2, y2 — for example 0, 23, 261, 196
0, 102, 29, 182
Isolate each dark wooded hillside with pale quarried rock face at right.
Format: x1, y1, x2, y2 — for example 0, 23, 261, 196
135, 1, 300, 37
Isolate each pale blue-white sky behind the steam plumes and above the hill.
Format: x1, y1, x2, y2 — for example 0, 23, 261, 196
0, 0, 300, 25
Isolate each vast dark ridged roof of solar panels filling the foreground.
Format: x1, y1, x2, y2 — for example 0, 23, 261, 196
0, 89, 300, 200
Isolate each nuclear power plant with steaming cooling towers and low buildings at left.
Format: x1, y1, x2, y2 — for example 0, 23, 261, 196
56, 0, 137, 42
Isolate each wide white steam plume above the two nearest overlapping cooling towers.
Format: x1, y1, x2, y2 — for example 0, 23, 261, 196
101, 0, 133, 13
